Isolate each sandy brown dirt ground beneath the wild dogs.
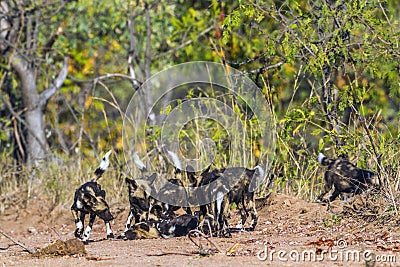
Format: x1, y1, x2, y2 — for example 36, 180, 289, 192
0, 193, 400, 267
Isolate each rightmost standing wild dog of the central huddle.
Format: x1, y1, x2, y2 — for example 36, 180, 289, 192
200, 166, 264, 237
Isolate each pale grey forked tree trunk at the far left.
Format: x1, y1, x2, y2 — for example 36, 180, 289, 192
0, 0, 68, 166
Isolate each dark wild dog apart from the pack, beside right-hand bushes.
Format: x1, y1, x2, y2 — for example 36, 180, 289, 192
318, 153, 378, 202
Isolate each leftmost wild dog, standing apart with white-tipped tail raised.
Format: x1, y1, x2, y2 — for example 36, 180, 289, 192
71, 150, 114, 242
